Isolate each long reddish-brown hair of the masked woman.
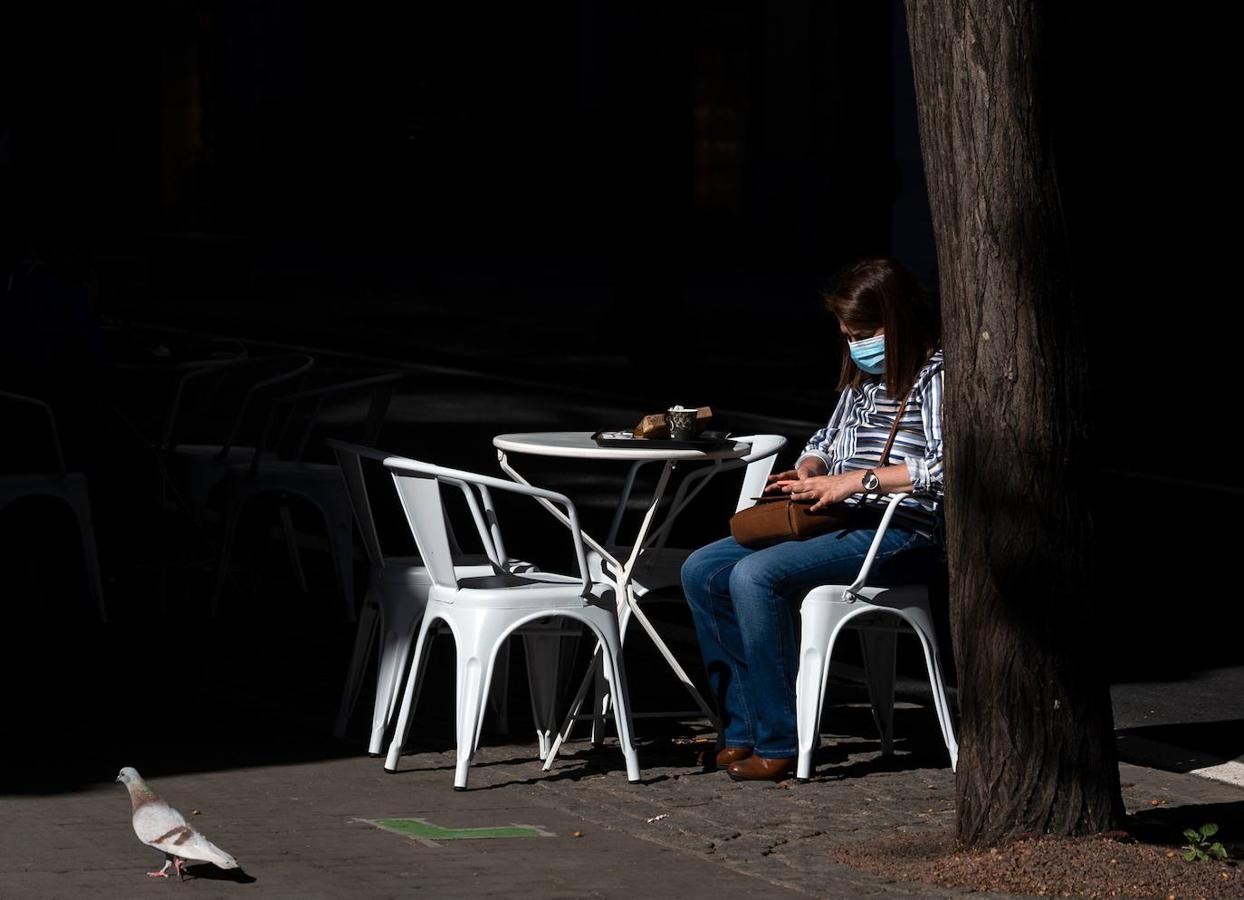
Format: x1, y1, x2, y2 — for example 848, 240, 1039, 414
824, 258, 940, 398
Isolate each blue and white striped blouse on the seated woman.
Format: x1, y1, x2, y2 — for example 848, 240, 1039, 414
796, 350, 943, 538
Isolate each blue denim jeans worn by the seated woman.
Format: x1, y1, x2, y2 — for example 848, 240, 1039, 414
683, 525, 933, 759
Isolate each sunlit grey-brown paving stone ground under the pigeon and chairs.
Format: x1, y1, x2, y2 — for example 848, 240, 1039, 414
0, 737, 1244, 898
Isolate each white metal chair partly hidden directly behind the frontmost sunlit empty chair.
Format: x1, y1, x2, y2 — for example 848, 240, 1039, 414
327, 439, 560, 759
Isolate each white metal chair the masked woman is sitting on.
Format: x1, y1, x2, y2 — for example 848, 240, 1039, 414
795, 494, 959, 780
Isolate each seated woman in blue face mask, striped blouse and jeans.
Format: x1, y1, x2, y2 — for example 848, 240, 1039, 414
682, 259, 942, 780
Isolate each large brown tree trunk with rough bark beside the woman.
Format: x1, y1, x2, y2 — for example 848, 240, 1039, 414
907, 0, 1122, 846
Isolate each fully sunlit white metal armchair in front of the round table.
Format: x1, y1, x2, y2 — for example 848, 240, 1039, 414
384, 457, 639, 790
